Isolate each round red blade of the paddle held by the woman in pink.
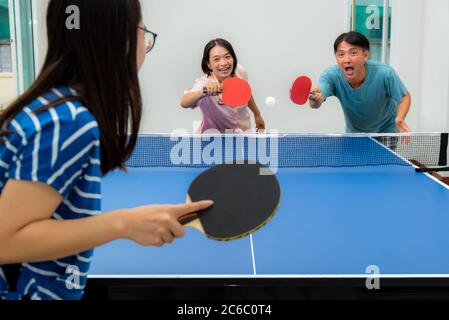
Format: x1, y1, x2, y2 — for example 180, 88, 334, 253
221, 77, 253, 107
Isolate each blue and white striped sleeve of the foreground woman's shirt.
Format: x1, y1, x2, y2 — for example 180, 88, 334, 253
8, 114, 99, 198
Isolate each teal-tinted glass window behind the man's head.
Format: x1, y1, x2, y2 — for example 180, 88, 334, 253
351, 0, 391, 63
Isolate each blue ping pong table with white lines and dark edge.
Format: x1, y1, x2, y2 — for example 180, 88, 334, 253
87, 136, 449, 299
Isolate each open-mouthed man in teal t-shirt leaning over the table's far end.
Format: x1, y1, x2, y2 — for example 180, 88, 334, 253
309, 32, 411, 133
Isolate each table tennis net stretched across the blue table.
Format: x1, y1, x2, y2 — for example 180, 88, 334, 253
127, 133, 448, 168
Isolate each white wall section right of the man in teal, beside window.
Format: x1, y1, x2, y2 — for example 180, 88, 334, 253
391, 0, 449, 132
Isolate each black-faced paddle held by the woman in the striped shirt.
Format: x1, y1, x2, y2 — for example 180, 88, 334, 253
179, 163, 281, 241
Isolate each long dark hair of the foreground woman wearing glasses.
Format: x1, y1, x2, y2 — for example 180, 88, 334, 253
0, 0, 142, 174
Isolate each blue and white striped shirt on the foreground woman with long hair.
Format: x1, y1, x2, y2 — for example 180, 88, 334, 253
0, 87, 101, 300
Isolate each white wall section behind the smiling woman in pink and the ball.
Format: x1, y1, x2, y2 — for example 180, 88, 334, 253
141, 0, 348, 132
